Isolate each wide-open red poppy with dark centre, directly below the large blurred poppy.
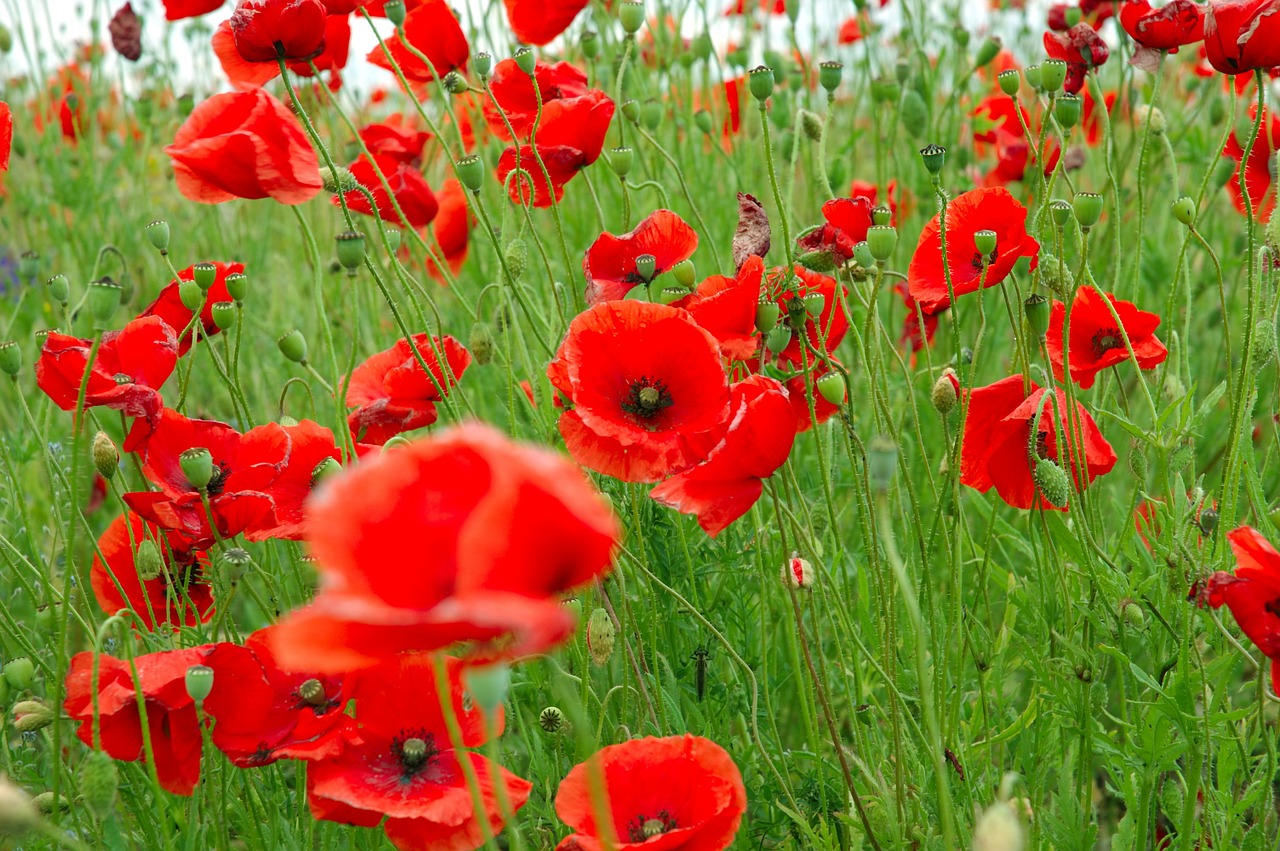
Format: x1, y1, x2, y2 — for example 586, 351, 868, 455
307, 654, 532, 851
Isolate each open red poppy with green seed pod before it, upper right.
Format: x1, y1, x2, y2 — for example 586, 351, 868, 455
906, 187, 1039, 314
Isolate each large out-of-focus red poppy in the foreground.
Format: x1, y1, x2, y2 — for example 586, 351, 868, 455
274, 425, 618, 672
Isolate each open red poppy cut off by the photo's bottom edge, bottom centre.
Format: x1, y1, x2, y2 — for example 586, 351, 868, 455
556, 733, 746, 851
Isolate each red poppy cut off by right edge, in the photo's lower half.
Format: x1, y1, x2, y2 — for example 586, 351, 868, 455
1203, 526, 1280, 695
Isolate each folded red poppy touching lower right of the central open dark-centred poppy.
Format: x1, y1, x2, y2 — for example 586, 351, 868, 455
649, 375, 796, 537
